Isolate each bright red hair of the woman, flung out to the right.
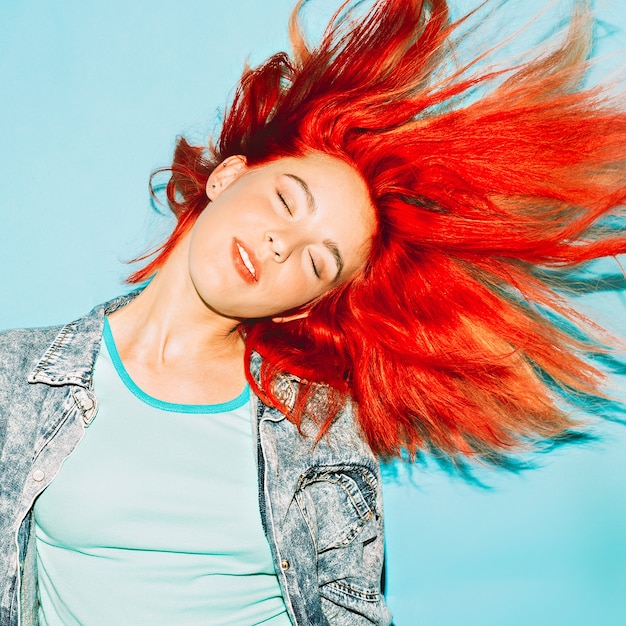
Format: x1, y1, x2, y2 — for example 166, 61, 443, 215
130, 0, 626, 462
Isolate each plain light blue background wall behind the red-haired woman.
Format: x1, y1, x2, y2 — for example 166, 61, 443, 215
0, 0, 626, 626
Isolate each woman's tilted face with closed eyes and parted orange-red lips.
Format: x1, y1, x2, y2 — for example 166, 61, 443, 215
189, 153, 376, 319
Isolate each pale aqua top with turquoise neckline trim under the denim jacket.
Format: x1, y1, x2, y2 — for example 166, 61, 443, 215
34, 324, 291, 626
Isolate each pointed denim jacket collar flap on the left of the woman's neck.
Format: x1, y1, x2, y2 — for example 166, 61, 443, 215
28, 289, 141, 388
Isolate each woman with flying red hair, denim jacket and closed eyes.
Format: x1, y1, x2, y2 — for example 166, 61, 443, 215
0, 1, 625, 624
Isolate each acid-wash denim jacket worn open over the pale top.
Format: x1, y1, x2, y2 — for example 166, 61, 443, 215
0, 294, 391, 626
